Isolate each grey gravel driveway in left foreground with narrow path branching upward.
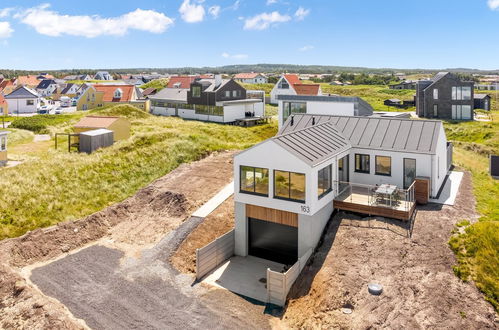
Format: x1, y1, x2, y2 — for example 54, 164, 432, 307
31, 217, 270, 329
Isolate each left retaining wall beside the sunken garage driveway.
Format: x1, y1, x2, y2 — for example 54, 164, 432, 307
196, 229, 234, 280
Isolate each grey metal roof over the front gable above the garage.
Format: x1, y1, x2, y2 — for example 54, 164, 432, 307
273, 118, 351, 166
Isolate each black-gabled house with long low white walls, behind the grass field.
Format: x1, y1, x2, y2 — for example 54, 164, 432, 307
149, 76, 265, 123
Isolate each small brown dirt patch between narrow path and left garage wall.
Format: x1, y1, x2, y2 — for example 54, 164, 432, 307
171, 197, 234, 274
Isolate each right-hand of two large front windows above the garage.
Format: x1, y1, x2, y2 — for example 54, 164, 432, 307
274, 170, 305, 203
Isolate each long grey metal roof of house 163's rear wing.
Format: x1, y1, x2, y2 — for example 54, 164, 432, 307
279, 114, 443, 154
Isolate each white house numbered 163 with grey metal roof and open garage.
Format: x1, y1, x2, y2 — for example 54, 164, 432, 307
234, 114, 452, 270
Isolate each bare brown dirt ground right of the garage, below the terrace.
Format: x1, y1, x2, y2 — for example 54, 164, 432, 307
282, 173, 499, 329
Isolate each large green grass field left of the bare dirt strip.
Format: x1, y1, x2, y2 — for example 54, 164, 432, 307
0, 108, 277, 239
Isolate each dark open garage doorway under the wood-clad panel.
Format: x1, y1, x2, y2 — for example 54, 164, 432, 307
248, 218, 298, 265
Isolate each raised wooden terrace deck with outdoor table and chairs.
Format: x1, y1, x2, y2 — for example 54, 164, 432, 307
334, 183, 416, 221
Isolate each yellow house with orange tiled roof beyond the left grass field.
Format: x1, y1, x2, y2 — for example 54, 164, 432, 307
76, 85, 150, 112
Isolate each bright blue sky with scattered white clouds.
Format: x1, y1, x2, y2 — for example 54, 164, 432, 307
0, 0, 499, 70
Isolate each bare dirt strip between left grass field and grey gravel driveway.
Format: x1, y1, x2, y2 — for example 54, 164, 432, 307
0, 152, 274, 329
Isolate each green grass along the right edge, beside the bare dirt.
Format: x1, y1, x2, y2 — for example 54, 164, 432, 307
444, 110, 499, 311
